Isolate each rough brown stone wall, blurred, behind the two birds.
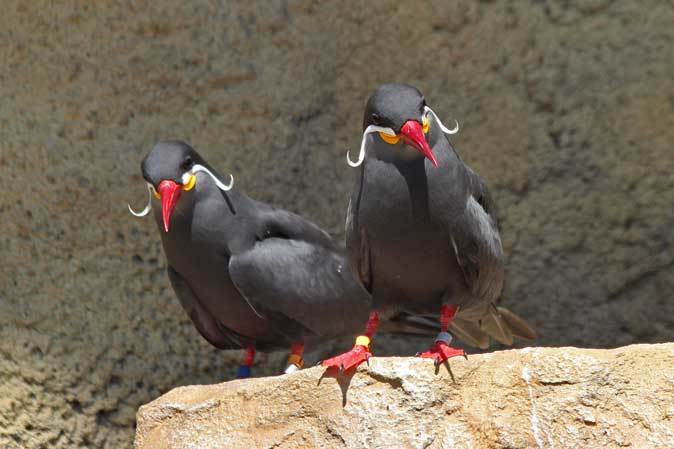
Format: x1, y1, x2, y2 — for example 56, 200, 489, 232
0, 0, 674, 448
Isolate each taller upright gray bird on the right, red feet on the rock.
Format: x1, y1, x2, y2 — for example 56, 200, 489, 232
322, 84, 536, 370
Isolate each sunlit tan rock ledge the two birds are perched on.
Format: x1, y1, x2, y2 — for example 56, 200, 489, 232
136, 344, 674, 449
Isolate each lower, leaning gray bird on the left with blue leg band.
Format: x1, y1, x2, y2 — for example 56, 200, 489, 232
129, 141, 432, 378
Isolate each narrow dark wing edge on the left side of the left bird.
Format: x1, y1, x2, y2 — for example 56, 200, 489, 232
167, 266, 241, 349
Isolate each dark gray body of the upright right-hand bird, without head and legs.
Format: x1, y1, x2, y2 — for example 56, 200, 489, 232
346, 103, 504, 321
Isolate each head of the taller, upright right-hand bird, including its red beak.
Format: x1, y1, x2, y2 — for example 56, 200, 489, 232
363, 84, 438, 167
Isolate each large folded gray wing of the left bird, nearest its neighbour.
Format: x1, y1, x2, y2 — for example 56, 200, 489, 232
229, 237, 370, 339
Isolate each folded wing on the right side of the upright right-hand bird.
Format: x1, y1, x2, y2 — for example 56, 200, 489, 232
451, 167, 504, 301
